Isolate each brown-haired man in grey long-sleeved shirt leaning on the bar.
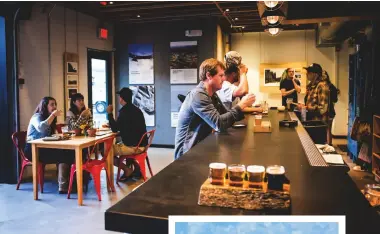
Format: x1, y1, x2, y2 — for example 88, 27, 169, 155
174, 58, 255, 159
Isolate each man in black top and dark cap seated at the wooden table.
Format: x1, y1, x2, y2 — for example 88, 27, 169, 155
107, 88, 148, 181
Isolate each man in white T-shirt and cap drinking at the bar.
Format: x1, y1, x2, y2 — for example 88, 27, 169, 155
216, 51, 263, 114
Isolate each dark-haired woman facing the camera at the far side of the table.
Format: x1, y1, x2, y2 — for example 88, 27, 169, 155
66, 93, 92, 130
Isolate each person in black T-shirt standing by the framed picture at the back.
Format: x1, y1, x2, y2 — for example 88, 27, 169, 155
280, 68, 301, 109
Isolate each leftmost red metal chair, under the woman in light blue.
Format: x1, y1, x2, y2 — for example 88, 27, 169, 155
12, 131, 45, 193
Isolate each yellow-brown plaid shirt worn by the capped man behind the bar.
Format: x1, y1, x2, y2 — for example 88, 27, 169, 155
305, 81, 330, 122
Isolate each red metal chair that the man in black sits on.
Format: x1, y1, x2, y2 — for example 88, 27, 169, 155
116, 129, 156, 183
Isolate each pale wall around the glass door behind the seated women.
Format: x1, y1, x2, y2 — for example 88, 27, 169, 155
19, 3, 113, 130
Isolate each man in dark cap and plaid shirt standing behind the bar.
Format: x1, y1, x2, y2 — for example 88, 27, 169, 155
299, 63, 330, 123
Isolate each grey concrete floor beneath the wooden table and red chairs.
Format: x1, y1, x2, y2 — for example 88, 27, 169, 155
0, 139, 374, 234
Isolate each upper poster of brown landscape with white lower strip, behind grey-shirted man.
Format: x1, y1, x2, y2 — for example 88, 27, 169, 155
170, 41, 198, 84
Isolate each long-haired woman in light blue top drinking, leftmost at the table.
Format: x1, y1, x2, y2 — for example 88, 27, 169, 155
24, 97, 75, 194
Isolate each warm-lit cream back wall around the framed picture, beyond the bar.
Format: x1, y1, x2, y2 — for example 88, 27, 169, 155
231, 30, 349, 135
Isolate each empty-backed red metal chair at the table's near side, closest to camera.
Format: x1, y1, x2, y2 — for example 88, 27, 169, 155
67, 136, 115, 201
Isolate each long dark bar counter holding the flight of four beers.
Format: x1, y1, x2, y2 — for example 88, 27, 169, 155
105, 110, 380, 234
